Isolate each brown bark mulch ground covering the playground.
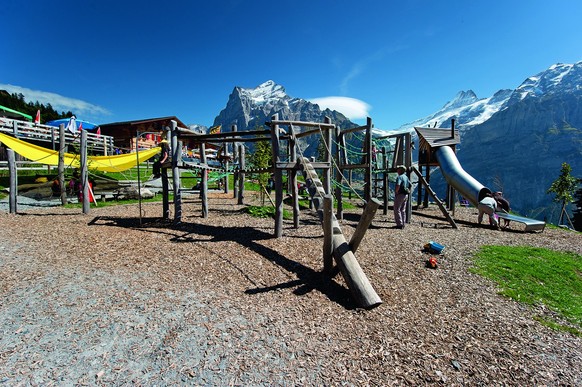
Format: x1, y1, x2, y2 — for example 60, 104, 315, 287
0, 195, 582, 386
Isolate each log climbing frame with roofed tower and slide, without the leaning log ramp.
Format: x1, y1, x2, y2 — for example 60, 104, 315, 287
157, 117, 545, 233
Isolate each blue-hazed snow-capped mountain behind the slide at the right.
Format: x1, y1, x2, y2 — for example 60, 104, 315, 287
422, 62, 582, 224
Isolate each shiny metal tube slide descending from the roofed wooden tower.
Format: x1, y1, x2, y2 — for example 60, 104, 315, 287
435, 146, 546, 231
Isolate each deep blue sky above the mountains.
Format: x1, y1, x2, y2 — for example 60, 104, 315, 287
0, 0, 582, 130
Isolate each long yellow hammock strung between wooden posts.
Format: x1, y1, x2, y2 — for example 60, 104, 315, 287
0, 133, 160, 172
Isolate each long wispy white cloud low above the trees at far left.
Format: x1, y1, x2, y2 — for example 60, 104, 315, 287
0, 84, 111, 118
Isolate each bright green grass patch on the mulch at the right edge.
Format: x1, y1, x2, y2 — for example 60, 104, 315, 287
471, 249, 582, 337
